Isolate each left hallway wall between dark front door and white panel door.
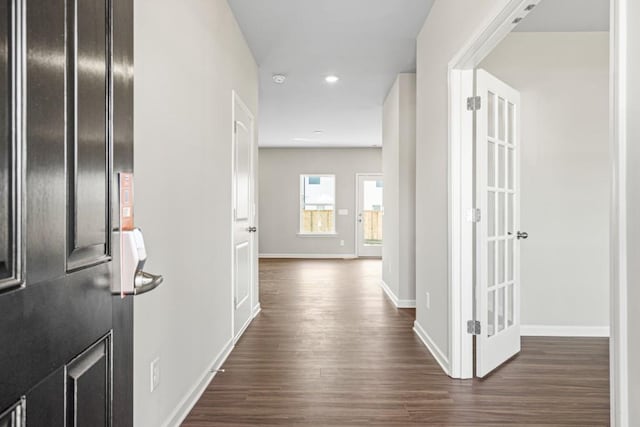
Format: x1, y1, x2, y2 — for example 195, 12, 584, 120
134, 0, 258, 427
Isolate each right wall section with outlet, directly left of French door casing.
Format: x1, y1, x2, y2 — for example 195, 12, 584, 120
416, 0, 507, 369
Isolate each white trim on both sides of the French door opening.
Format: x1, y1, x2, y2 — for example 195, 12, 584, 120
448, 0, 630, 426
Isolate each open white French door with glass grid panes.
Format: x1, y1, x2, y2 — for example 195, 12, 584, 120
475, 70, 526, 377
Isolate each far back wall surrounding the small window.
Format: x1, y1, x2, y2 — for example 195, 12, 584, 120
258, 148, 382, 255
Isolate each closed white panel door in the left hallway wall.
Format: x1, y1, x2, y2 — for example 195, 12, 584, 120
232, 94, 257, 339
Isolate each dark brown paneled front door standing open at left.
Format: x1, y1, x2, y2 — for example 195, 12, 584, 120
0, 0, 133, 427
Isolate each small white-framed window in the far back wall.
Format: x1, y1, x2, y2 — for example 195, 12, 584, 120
300, 175, 336, 234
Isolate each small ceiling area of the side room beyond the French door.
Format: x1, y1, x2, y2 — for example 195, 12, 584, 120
515, 0, 609, 32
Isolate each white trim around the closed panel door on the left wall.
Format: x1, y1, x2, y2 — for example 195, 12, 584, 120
230, 90, 259, 344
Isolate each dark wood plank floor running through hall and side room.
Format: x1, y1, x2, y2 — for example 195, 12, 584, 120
183, 260, 609, 427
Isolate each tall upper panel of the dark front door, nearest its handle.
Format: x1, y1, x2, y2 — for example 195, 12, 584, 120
67, 0, 110, 270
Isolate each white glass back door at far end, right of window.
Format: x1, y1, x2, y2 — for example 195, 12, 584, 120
356, 174, 383, 257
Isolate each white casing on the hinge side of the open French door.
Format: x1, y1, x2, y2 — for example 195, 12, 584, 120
448, 0, 540, 378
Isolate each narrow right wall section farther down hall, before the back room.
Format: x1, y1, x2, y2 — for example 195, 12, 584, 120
382, 74, 416, 305
